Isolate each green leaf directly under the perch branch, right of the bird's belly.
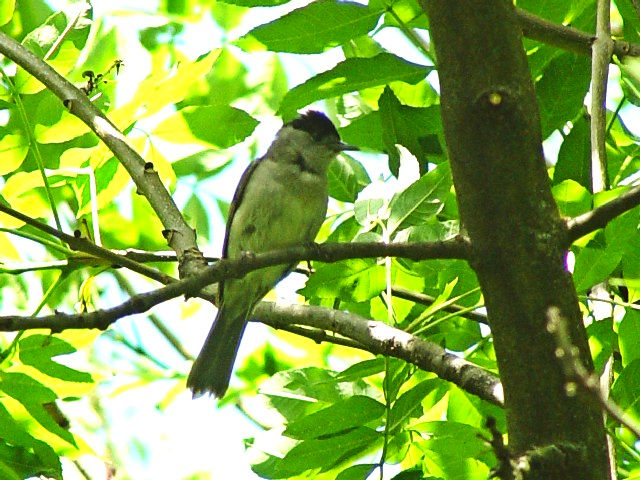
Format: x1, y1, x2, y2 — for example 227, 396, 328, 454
298, 259, 386, 302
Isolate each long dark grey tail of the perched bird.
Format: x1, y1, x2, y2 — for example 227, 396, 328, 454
187, 306, 247, 398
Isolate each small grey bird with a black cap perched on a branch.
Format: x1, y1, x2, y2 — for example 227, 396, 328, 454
187, 110, 357, 398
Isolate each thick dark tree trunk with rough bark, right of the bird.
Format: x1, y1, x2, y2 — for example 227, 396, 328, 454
422, 0, 609, 480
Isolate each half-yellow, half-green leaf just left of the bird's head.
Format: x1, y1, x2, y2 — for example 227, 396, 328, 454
153, 105, 258, 148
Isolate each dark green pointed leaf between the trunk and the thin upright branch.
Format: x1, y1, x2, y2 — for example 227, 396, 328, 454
553, 115, 591, 191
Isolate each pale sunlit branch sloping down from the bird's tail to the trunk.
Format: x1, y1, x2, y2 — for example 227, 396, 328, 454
254, 302, 504, 406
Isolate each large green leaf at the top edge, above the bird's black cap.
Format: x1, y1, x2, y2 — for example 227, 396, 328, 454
235, 0, 384, 53
